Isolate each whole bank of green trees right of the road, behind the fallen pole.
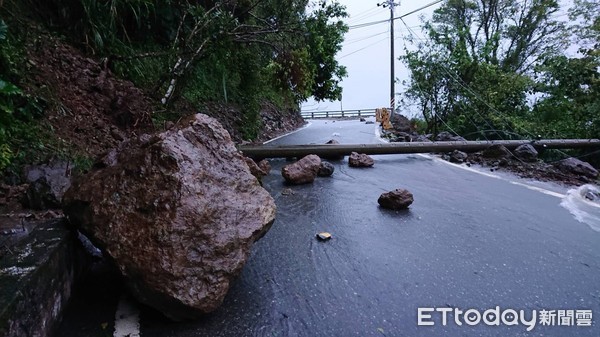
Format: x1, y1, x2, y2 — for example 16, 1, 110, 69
401, 0, 600, 164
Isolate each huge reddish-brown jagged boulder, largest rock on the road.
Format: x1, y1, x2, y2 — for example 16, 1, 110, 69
64, 114, 275, 320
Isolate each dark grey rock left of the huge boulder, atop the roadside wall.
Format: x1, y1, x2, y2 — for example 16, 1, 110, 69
22, 161, 71, 210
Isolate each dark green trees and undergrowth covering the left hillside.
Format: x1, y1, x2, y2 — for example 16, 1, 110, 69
0, 0, 347, 176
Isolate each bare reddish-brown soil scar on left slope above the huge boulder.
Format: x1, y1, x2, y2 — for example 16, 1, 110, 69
28, 36, 153, 157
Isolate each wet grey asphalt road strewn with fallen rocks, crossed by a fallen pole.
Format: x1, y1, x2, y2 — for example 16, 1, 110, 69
59, 121, 600, 337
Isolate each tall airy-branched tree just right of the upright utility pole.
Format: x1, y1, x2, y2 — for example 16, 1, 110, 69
402, 0, 564, 138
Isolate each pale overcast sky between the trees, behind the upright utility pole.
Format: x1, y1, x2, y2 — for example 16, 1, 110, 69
302, 0, 441, 111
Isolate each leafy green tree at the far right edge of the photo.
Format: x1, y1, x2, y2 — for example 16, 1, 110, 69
531, 0, 600, 138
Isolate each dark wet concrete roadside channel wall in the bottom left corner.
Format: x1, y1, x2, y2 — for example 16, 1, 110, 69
0, 219, 85, 337
